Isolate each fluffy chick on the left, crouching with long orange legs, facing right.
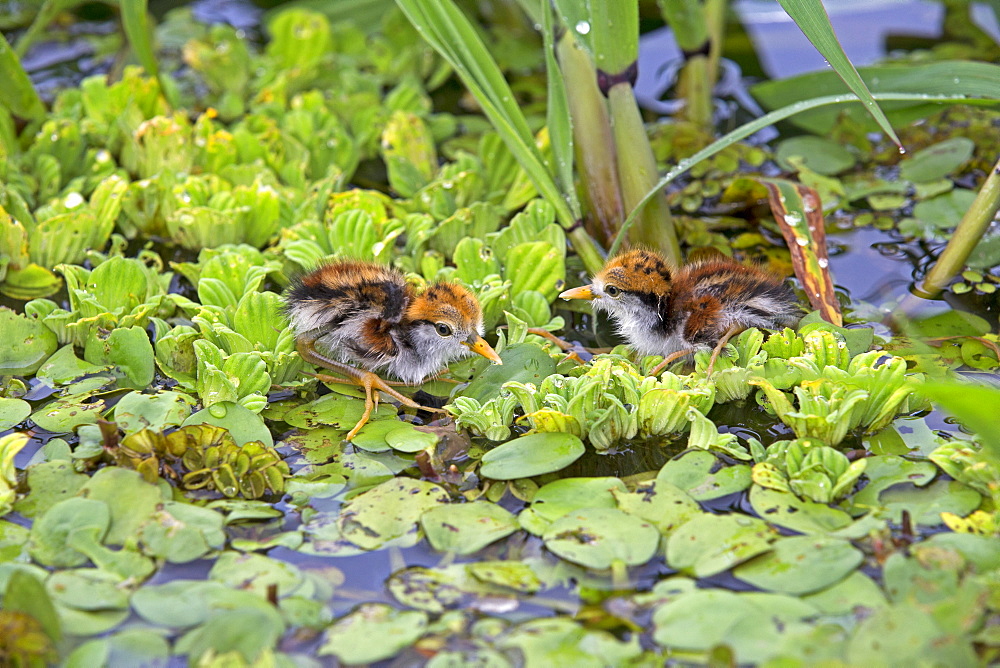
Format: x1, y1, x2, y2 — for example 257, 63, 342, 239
285, 261, 502, 440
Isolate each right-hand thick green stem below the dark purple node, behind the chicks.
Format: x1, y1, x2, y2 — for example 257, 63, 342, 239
608, 81, 681, 264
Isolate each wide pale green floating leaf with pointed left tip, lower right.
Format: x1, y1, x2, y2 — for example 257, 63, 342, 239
733, 536, 864, 595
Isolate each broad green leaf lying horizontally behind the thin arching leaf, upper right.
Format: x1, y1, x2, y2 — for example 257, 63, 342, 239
750, 60, 1000, 134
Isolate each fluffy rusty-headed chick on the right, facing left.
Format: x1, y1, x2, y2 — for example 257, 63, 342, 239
559, 249, 801, 374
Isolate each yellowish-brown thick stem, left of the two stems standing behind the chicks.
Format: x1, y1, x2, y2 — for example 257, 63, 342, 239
556, 31, 625, 244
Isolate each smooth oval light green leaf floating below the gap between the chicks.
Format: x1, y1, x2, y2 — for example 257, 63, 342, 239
480, 433, 586, 480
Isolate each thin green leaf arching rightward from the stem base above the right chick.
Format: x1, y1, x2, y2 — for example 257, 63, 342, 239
608, 93, 976, 256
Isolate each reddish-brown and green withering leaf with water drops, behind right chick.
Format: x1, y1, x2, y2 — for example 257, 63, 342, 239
758, 179, 844, 326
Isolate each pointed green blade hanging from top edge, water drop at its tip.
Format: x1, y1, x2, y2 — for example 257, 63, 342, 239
778, 0, 903, 148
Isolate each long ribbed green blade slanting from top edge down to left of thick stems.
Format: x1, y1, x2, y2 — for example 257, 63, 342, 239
396, 0, 576, 227
